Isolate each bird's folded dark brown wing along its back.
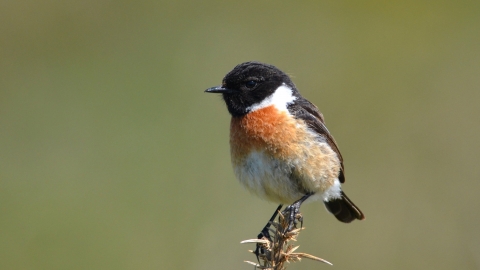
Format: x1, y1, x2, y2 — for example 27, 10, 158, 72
288, 97, 345, 183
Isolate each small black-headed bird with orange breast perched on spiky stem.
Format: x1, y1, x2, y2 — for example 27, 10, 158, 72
205, 61, 365, 232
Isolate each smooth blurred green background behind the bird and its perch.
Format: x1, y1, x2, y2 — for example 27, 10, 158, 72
0, 0, 480, 270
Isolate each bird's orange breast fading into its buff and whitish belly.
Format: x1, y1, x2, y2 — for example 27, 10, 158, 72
230, 103, 340, 198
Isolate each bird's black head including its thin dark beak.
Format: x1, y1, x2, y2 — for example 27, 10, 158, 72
205, 62, 297, 116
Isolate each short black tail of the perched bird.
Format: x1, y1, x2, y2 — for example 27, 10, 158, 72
324, 191, 365, 223
